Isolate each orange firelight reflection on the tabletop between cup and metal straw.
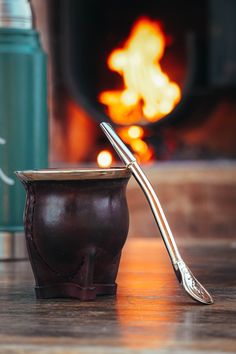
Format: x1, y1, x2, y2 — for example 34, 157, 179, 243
116, 239, 179, 349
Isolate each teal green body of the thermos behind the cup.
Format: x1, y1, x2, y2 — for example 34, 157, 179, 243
0, 28, 48, 232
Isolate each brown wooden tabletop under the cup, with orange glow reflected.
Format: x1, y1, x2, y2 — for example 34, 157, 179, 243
0, 238, 236, 354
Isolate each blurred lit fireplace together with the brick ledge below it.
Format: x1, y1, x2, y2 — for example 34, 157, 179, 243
32, 0, 236, 238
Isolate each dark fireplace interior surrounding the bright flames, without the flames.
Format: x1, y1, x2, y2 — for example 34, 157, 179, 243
31, 0, 236, 162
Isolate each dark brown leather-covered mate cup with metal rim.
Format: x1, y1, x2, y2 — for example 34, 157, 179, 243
16, 168, 130, 300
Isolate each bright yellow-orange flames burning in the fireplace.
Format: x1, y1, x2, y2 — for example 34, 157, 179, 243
99, 18, 181, 162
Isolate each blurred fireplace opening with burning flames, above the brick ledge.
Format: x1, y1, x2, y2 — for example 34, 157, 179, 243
30, 0, 236, 164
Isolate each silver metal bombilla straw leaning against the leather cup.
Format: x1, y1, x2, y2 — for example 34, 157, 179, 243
100, 122, 213, 305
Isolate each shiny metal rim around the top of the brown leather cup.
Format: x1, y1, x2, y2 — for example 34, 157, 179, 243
15, 167, 131, 182
